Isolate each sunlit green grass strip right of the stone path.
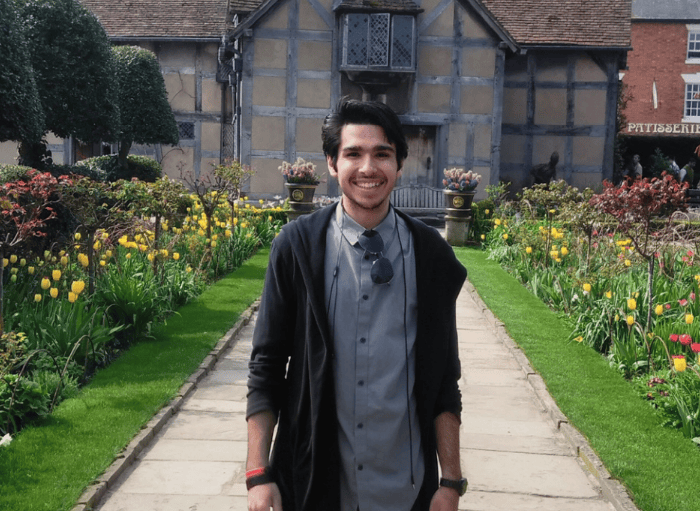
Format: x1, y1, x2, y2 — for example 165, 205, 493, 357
455, 248, 700, 511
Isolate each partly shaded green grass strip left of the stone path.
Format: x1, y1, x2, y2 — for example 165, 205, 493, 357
0, 250, 269, 511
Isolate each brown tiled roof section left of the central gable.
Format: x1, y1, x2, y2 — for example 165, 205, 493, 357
79, 0, 230, 39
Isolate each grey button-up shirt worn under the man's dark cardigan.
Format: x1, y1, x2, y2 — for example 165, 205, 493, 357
325, 206, 425, 511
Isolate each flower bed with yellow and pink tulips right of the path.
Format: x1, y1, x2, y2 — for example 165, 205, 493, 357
484, 178, 700, 443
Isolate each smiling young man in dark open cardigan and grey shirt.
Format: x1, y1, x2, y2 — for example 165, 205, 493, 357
246, 100, 466, 511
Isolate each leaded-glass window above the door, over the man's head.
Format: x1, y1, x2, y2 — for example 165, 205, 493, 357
343, 13, 415, 71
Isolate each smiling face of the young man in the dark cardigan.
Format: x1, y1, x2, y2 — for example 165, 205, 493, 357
327, 124, 401, 225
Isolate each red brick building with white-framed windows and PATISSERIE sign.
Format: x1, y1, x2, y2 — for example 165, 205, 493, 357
622, 0, 700, 178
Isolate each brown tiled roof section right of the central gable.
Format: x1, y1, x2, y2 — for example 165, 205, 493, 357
477, 0, 632, 48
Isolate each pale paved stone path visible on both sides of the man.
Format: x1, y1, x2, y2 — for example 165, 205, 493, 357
85, 282, 636, 511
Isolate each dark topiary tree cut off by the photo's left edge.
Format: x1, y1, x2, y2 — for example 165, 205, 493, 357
0, 0, 44, 146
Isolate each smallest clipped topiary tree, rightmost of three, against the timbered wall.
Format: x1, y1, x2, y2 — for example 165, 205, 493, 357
112, 46, 179, 169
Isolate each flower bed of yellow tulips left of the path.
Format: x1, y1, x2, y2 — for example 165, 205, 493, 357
0, 171, 285, 442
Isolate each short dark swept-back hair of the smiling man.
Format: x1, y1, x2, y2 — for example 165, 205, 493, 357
321, 98, 408, 169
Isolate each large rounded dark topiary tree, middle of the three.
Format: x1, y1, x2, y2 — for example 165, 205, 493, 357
18, 0, 119, 168
